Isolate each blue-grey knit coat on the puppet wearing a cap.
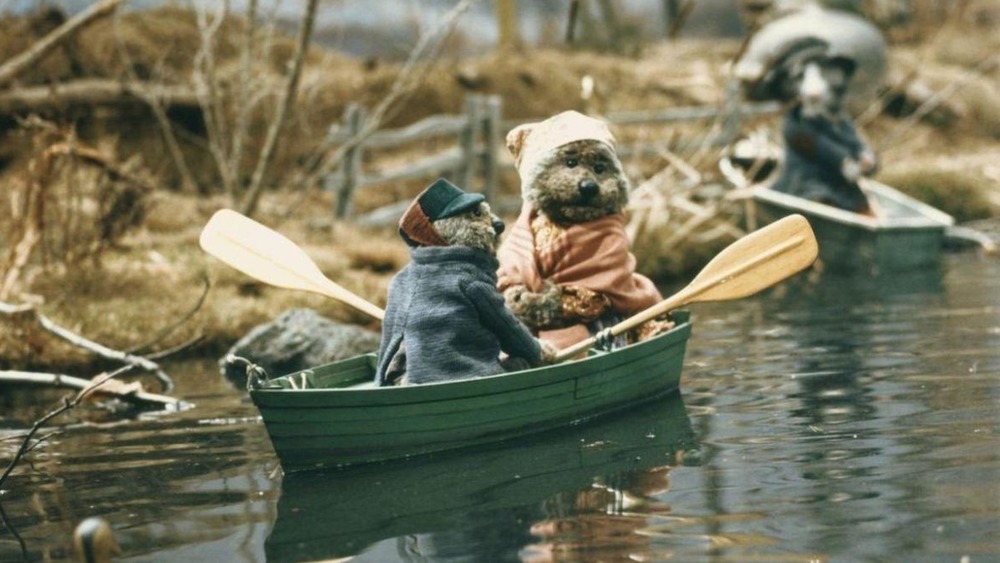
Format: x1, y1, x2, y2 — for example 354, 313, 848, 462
375, 246, 541, 385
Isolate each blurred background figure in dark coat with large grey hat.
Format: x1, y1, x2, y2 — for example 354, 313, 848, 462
734, 3, 888, 213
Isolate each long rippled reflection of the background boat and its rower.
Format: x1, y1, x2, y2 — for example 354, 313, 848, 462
768, 268, 944, 553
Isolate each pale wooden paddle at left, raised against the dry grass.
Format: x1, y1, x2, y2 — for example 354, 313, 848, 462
198, 209, 385, 320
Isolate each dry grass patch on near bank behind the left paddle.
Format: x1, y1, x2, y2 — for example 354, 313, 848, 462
0, 194, 398, 369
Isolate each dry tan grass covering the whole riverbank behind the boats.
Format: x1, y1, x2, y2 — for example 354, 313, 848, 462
0, 8, 1000, 374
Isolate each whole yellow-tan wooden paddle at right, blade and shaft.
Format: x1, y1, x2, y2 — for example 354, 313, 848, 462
555, 215, 819, 362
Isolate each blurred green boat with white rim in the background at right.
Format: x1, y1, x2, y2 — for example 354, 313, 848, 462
753, 180, 954, 274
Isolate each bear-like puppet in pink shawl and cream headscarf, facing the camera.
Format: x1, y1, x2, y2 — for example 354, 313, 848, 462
497, 111, 667, 348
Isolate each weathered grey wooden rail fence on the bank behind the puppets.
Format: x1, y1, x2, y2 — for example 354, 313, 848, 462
325, 87, 781, 225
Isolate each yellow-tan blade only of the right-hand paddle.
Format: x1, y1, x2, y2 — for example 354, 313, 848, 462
688, 215, 819, 303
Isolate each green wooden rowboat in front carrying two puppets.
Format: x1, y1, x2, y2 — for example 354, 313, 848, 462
250, 311, 691, 473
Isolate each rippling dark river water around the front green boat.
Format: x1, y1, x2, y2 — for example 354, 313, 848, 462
0, 253, 1000, 563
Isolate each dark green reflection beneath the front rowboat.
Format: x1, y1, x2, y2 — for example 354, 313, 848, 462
265, 393, 697, 561
